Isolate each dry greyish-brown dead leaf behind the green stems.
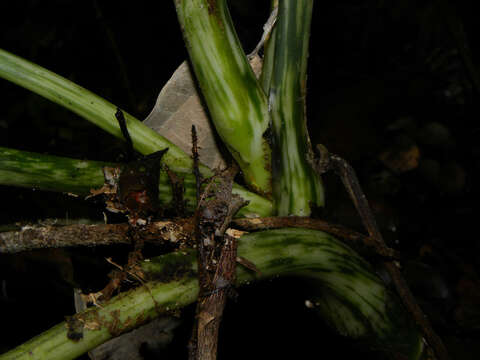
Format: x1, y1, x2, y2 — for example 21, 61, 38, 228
144, 55, 262, 169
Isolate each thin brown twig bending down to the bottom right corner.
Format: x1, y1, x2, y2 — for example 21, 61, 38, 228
316, 146, 449, 360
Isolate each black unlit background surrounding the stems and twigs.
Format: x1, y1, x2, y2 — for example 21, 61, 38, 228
0, 0, 480, 359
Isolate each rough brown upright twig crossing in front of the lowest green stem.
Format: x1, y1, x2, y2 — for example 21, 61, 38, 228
189, 167, 246, 360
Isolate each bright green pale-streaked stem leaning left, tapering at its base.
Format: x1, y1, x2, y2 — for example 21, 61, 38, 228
175, 0, 271, 196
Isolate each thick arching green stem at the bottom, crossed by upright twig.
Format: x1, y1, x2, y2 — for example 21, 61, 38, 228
0, 229, 422, 360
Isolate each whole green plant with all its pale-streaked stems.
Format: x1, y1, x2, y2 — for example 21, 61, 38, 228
0, 0, 428, 360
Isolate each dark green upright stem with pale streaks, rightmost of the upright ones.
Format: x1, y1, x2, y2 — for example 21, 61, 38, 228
262, 0, 324, 216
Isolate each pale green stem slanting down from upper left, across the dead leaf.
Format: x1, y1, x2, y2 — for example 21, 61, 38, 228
0, 49, 192, 175
